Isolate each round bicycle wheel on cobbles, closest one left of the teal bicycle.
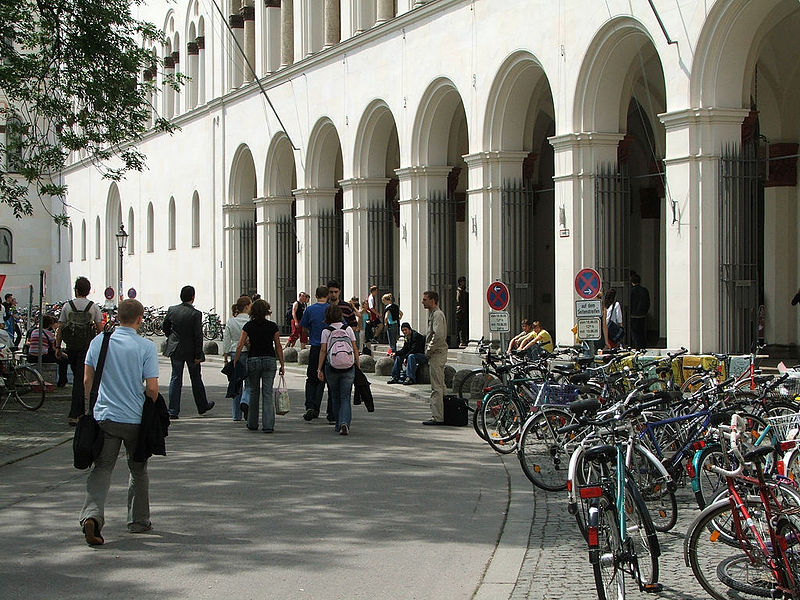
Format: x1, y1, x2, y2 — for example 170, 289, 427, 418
517, 406, 573, 492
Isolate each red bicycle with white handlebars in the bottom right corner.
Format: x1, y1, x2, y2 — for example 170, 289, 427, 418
684, 415, 800, 600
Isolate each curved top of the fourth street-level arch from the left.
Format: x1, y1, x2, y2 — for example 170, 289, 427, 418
353, 100, 399, 177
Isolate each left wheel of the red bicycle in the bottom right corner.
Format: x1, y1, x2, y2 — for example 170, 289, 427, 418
684, 497, 769, 600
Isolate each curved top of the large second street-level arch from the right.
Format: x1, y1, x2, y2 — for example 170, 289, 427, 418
572, 17, 664, 132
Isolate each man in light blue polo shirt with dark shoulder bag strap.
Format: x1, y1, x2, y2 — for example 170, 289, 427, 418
80, 300, 158, 546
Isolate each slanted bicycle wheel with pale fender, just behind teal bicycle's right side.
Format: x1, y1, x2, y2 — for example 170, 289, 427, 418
630, 446, 678, 532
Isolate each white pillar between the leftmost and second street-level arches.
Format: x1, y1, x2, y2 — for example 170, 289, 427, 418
255, 196, 296, 304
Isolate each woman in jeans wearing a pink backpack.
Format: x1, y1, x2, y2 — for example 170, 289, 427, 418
317, 304, 359, 435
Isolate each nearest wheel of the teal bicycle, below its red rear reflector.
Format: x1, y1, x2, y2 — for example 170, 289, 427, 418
588, 494, 625, 600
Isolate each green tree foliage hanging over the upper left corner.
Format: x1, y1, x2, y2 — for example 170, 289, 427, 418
0, 0, 181, 222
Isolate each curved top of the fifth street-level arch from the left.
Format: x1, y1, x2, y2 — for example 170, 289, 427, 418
411, 77, 469, 166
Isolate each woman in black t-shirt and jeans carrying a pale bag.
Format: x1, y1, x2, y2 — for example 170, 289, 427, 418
233, 299, 284, 433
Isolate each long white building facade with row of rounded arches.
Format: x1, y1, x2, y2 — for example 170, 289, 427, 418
51, 0, 800, 352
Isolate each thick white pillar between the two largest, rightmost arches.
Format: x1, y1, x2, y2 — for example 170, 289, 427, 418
659, 108, 749, 352
